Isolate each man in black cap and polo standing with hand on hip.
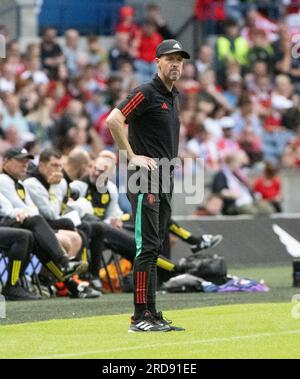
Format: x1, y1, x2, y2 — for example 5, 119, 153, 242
107, 40, 190, 332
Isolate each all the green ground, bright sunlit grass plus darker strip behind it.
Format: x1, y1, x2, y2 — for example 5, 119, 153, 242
0, 266, 300, 358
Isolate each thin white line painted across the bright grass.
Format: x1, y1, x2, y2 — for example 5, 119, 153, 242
28, 329, 300, 359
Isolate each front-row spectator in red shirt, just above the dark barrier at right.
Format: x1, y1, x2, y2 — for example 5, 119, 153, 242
253, 162, 282, 212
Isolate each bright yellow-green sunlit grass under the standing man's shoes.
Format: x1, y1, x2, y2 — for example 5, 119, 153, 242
0, 303, 300, 358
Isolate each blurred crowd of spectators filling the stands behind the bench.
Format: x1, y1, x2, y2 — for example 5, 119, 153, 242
0, 0, 300, 215
